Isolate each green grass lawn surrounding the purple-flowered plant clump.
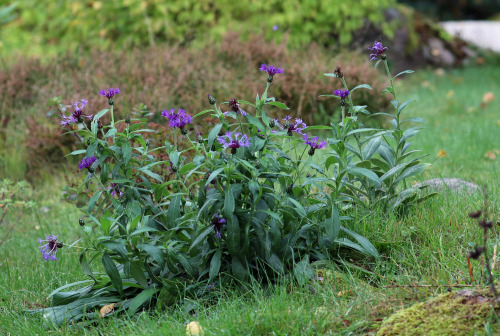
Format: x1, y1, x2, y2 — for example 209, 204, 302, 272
0, 66, 500, 336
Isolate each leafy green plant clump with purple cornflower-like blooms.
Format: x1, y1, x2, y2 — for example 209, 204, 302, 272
30, 42, 426, 323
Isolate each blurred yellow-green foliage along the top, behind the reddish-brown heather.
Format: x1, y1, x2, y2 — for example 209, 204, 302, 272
0, 0, 396, 49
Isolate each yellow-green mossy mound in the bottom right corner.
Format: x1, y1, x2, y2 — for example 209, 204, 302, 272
377, 289, 500, 336
